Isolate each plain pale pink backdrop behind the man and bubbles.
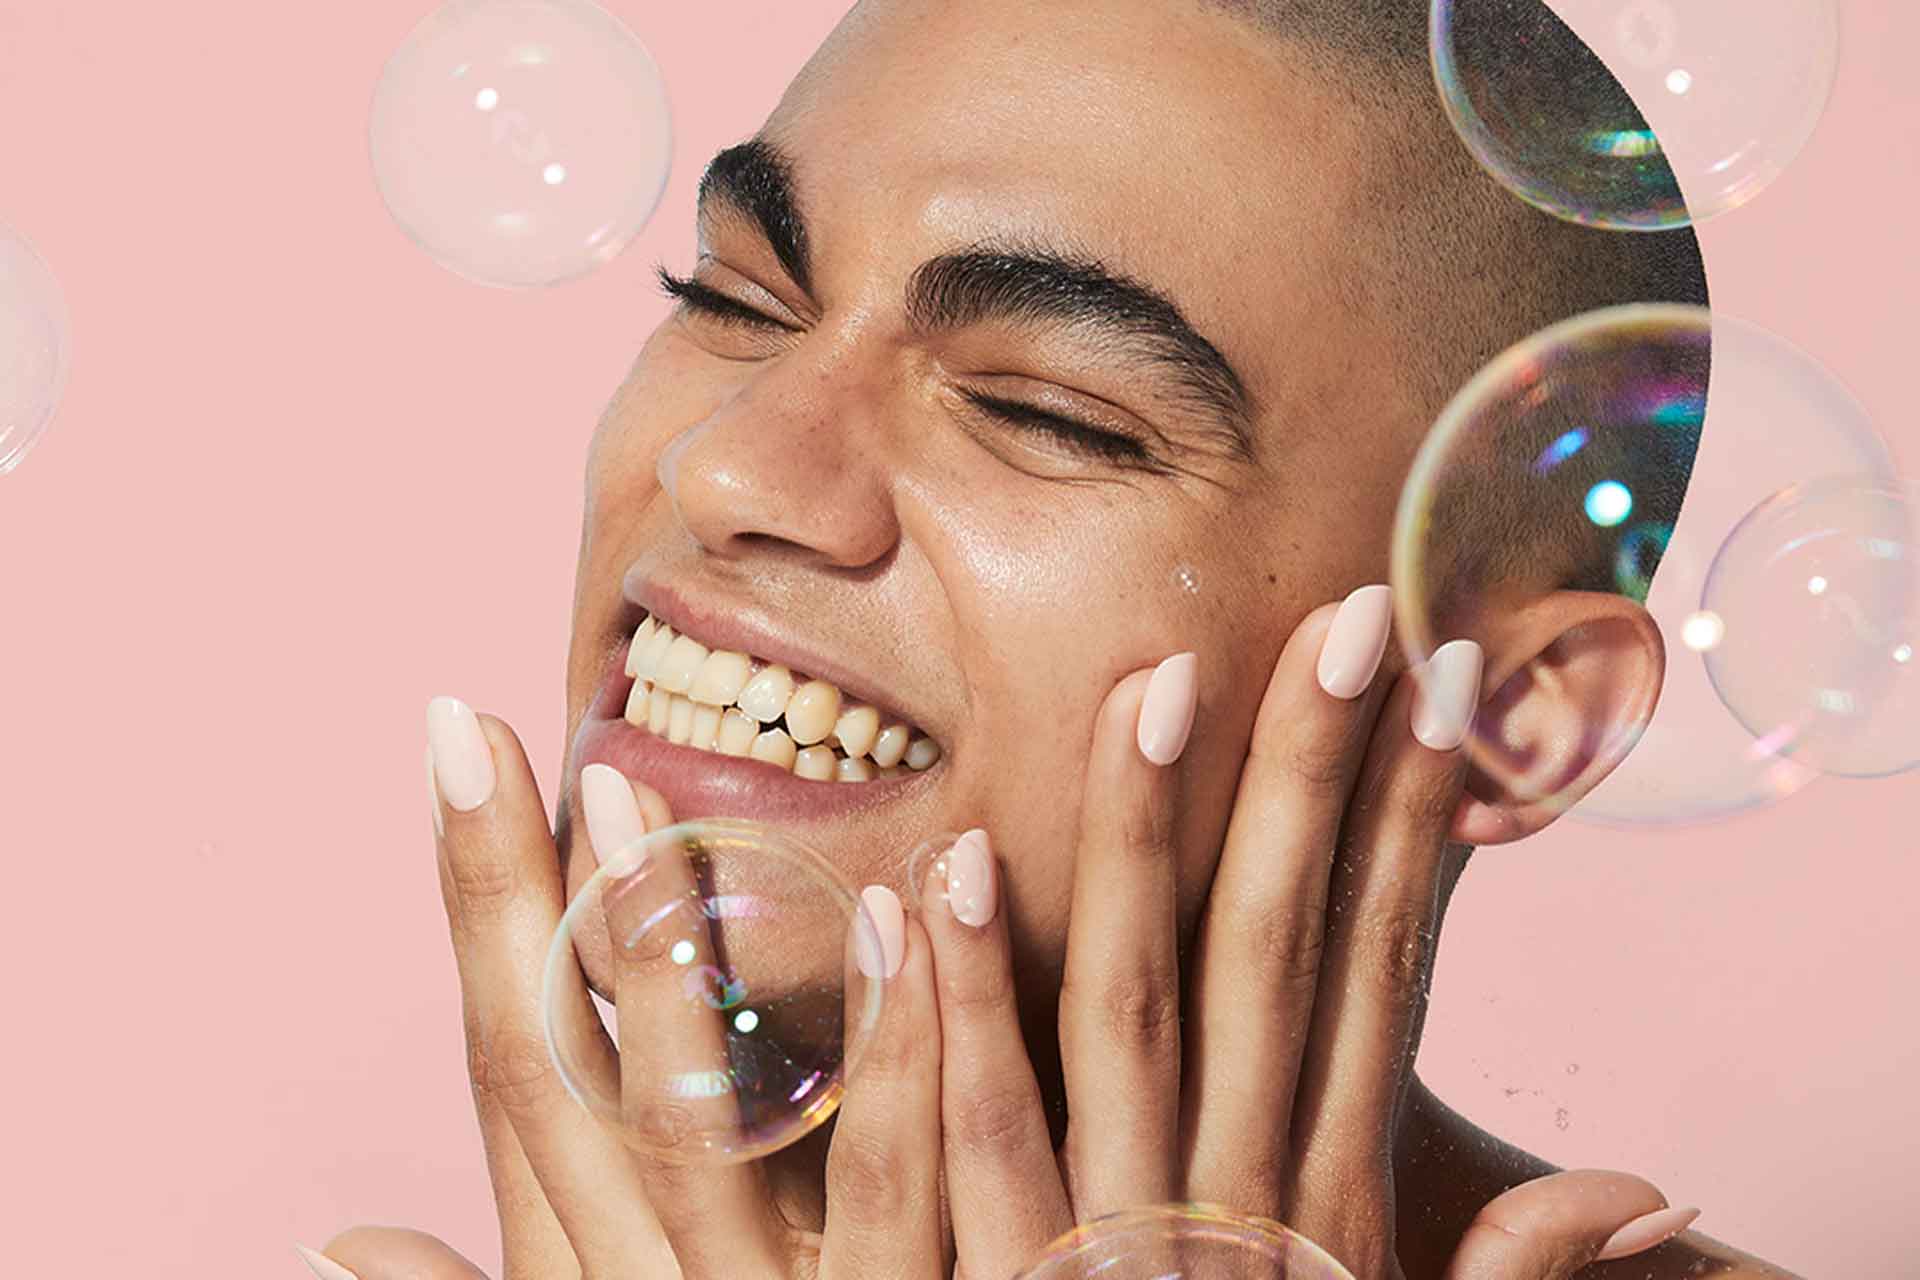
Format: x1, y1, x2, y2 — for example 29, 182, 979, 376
0, 0, 1920, 1278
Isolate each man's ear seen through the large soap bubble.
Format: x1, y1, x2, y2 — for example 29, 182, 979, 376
1452, 591, 1667, 844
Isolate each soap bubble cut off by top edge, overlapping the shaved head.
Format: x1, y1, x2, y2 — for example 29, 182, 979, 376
1428, 0, 1839, 230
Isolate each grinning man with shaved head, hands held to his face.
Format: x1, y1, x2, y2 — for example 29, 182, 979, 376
305, 0, 1782, 1280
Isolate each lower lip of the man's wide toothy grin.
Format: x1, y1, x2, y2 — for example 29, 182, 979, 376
572, 656, 939, 821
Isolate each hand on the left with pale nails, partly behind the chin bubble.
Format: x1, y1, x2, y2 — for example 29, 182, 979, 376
309, 699, 950, 1280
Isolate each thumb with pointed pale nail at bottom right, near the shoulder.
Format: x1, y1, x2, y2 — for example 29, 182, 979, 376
1446, 1169, 1699, 1280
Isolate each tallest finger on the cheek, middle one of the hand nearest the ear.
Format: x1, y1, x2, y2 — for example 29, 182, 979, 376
1181, 587, 1392, 1217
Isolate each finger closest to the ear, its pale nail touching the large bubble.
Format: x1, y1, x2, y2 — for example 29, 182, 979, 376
1294, 641, 1480, 1244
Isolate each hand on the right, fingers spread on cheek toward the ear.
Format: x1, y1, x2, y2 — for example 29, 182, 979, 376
894, 587, 1686, 1280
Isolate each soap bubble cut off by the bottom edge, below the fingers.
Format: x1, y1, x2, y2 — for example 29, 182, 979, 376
1014, 1203, 1352, 1280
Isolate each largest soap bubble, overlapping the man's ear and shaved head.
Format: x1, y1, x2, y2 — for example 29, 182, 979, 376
1392, 305, 1897, 823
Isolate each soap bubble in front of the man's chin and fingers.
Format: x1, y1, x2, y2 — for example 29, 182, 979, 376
541, 818, 885, 1163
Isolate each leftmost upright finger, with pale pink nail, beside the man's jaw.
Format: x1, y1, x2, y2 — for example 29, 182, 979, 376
428, 699, 672, 1276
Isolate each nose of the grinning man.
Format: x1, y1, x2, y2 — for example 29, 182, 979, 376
657, 349, 900, 568
